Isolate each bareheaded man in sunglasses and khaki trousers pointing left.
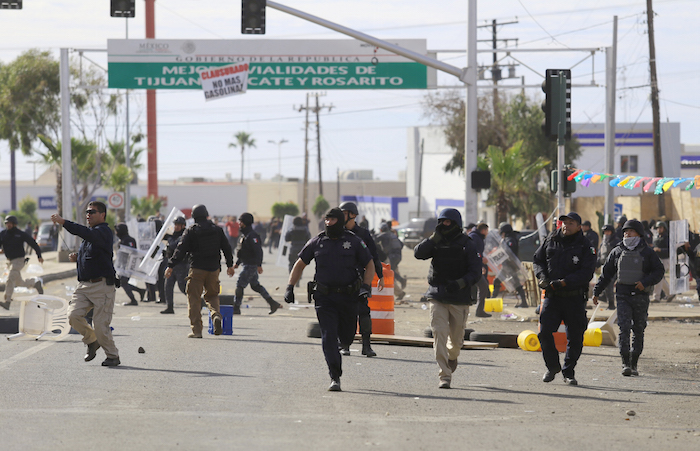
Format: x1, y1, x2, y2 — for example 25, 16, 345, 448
51, 202, 121, 366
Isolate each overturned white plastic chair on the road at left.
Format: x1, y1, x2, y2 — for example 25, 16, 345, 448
7, 295, 70, 340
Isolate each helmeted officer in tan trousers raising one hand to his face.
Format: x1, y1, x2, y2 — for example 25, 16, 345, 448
413, 208, 483, 388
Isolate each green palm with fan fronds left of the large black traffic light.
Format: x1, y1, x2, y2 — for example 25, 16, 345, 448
486, 140, 549, 222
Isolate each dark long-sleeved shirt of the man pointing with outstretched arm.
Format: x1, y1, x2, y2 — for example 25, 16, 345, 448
63, 221, 114, 282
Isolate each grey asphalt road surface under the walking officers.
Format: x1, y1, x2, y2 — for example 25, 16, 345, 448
0, 254, 700, 451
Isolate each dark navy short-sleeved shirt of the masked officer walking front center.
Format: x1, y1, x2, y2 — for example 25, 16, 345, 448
299, 230, 372, 287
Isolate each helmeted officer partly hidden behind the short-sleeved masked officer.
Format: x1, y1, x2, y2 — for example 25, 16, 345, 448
338, 202, 384, 357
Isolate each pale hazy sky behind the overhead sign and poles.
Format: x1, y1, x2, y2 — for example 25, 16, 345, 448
0, 0, 700, 185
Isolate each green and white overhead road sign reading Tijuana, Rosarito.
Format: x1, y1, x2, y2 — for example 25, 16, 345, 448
108, 39, 432, 90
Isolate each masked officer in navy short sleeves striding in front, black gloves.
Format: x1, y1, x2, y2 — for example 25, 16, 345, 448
284, 208, 374, 391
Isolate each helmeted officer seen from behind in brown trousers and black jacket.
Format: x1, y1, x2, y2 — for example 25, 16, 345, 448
165, 204, 234, 338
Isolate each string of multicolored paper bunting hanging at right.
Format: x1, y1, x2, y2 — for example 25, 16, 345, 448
567, 169, 700, 194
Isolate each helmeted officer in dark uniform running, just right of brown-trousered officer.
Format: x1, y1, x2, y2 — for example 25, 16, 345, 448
233, 213, 282, 315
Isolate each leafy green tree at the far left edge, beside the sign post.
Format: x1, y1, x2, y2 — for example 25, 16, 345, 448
0, 49, 60, 208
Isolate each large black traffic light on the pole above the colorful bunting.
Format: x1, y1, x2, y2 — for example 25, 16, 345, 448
542, 69, 571, 141
